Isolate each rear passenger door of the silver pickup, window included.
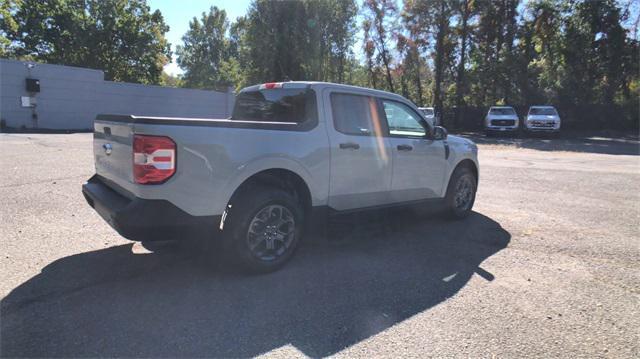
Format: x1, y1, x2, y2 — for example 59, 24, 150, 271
323, 90, 392, 210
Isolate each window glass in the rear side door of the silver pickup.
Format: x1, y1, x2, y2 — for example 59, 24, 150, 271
331, 93, 380, 136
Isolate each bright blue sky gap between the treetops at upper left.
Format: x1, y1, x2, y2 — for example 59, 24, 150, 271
147, 0, 250, 75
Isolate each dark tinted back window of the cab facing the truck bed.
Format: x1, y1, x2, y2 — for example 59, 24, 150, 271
231, 88, 316, 123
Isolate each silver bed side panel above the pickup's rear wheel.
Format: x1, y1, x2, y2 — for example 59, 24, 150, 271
128, 121, 329, 216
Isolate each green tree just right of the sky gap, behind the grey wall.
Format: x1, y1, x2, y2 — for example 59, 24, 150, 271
176, 6, 238, 90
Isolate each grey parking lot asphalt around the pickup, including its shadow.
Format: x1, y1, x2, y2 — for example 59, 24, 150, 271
0, 134, 640, 358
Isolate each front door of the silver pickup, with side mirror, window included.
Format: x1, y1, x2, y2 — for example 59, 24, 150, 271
381, 99, 447, 202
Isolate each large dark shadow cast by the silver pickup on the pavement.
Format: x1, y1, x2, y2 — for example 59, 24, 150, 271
0, 212, 511, 357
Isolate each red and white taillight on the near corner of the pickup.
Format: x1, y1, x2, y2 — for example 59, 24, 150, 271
133, 135, 176, 184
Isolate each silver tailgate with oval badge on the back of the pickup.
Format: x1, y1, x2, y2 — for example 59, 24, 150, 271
93, 116, 133, 194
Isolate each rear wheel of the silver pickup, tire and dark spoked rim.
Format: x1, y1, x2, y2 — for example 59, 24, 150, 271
225, 185, 304, 273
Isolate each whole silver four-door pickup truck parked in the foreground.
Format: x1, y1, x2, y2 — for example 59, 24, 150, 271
82, 82, 478, 272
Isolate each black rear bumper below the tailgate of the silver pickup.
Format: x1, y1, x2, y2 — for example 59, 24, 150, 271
82, 175, 220, 241
